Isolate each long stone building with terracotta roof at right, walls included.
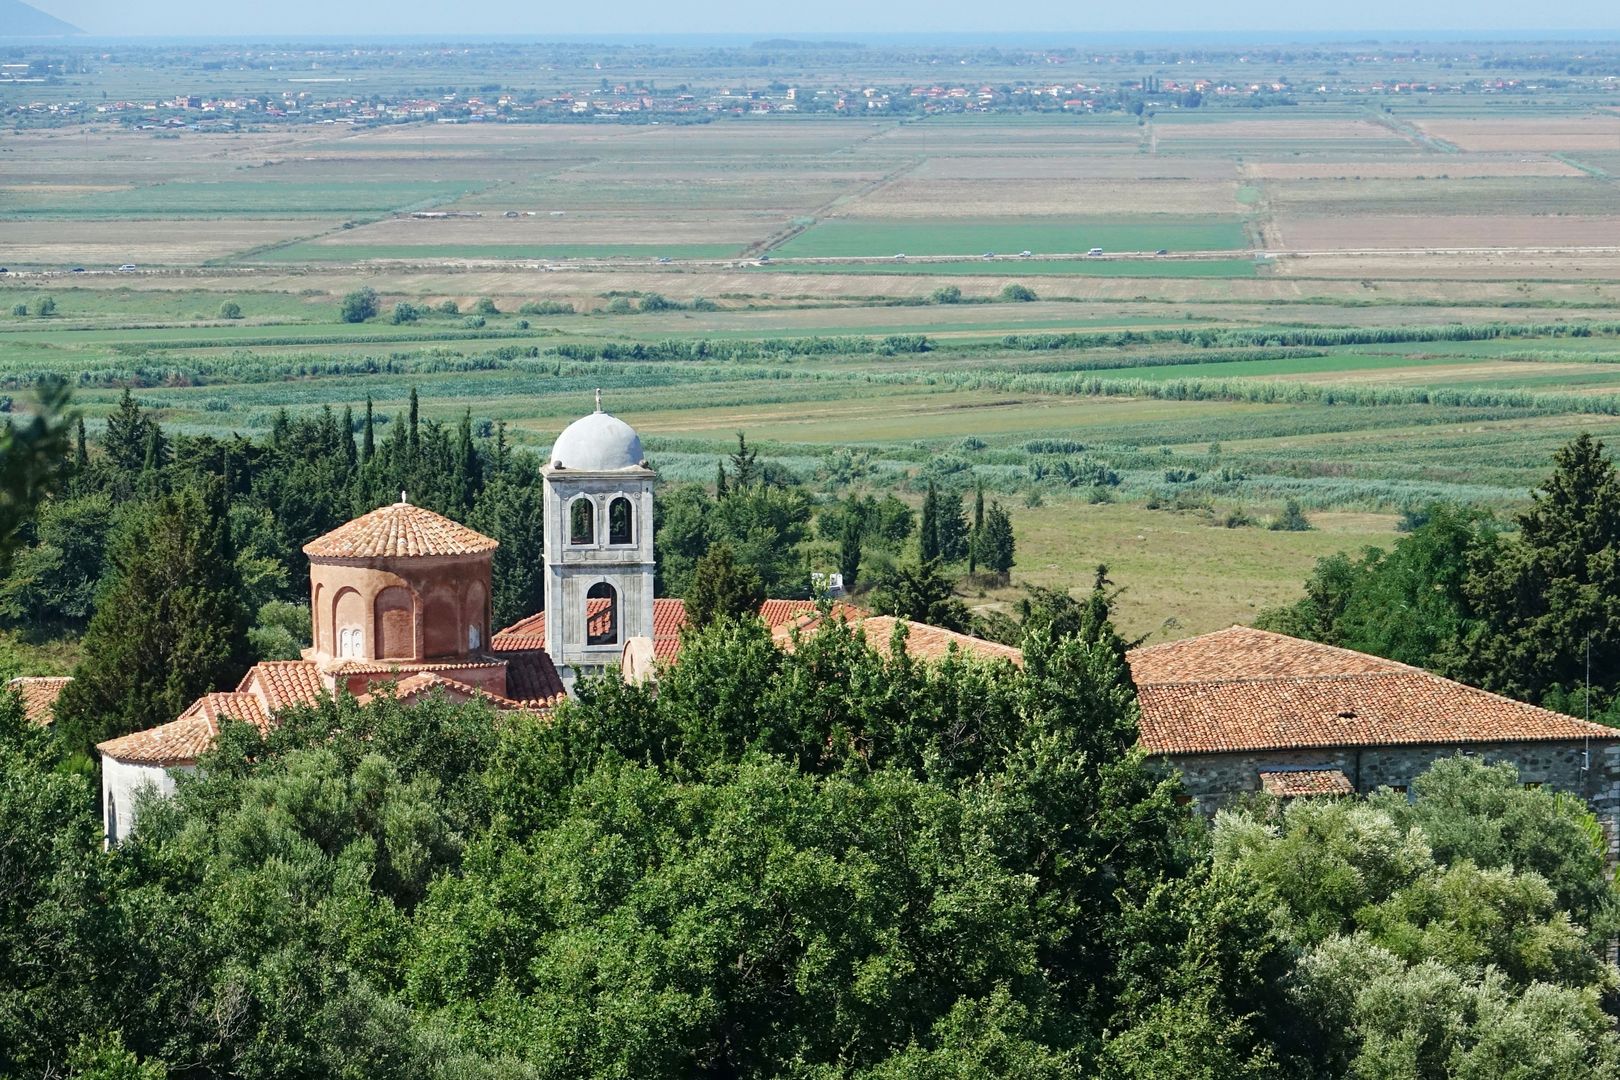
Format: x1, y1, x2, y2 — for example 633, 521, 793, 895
1129, 627, 1620, 837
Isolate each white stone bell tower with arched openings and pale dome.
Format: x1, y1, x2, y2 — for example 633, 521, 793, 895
541, 390, 656, 693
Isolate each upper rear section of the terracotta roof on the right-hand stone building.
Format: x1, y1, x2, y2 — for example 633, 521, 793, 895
1129, 627, 1418, 687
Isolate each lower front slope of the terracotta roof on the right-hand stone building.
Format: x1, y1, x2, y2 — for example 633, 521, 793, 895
1137, 669, 1620, 755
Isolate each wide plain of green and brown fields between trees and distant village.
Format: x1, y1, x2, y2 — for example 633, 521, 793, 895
0, 102, 1620, 635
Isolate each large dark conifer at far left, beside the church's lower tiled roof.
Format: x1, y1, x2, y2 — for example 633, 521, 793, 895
57, 479, 248, 750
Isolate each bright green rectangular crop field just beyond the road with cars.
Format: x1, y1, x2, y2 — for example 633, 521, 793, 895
771, 217, 1249, 259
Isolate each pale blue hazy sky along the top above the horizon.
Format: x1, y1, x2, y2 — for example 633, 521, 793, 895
31, 0, 1620, 37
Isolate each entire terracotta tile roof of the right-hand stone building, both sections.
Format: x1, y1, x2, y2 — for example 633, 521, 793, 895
1129, 628, 1620, 755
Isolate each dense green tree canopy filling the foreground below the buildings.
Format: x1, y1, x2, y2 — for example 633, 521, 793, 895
0, 602, 1620, 1080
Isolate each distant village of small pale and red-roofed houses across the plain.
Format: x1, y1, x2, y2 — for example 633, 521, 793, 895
0, 46, 1620, 130
